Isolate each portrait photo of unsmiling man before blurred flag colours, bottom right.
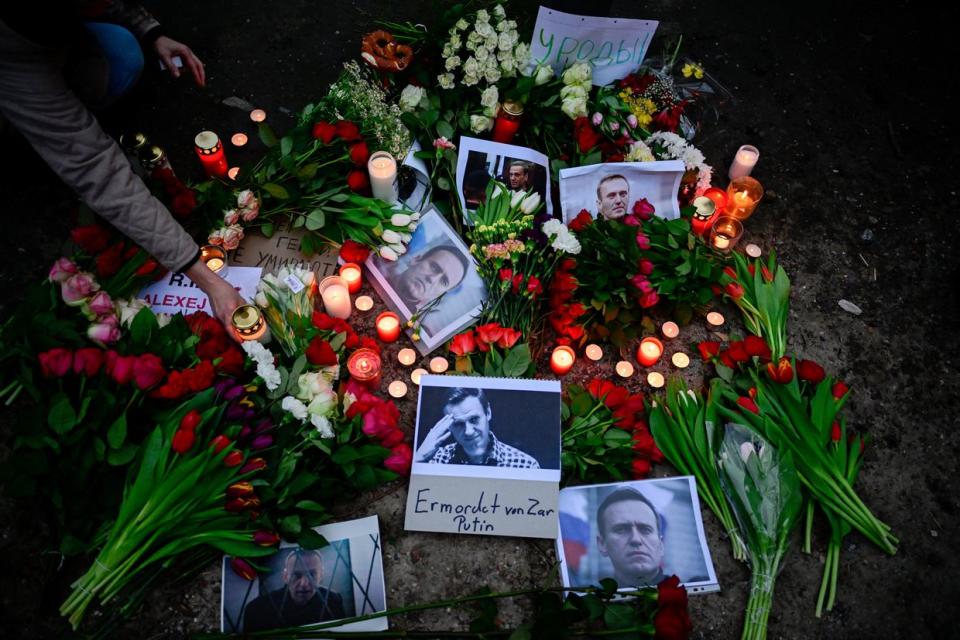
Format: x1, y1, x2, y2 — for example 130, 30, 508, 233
557, 476, 720, 593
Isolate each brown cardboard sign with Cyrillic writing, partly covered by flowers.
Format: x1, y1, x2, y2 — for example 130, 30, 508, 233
230, 222, 337, 278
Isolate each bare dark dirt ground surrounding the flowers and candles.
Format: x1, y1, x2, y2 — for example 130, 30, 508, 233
0, 0, 960, 640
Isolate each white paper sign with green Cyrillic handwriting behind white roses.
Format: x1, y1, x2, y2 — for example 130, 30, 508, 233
530, 7, 659, 86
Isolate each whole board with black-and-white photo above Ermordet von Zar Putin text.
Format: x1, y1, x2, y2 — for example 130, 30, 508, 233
404, 375, 560, 538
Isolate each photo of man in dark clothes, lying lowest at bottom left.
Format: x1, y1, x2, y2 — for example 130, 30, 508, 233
220, 516, 387, 633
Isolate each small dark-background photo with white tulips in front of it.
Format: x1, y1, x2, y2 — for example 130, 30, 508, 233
457, 136, 553, 224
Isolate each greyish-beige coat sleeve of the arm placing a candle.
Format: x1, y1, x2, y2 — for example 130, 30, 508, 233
0, 21, 198, 270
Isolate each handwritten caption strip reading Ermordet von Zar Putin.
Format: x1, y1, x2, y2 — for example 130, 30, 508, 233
404, 475, 560, 538
